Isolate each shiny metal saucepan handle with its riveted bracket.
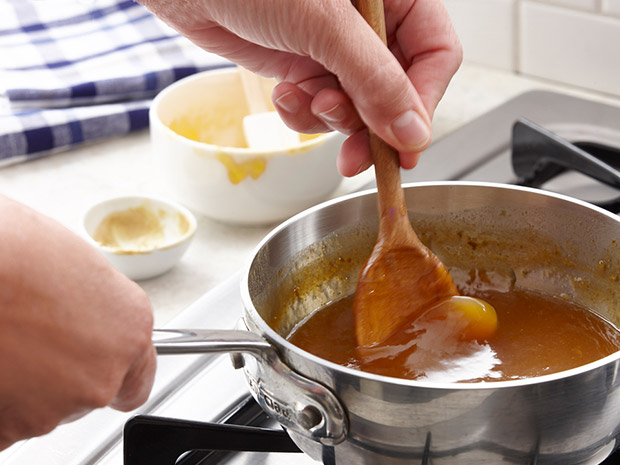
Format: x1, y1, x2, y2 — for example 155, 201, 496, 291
153, 329, 348, 446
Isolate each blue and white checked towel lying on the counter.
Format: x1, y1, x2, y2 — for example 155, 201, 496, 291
0, 0, 232, 166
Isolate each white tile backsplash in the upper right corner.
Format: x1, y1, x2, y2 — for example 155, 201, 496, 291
444, 0, 620, 95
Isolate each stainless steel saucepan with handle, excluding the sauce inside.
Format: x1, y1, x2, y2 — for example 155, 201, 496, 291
154, 182, 620, 465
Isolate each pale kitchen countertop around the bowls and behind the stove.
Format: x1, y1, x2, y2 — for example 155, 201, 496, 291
0, 65, 620, 326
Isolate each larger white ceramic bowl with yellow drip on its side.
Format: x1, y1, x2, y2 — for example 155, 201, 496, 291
150, 68, 345, 225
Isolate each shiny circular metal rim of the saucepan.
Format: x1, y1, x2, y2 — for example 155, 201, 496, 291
241, 181, 620, 390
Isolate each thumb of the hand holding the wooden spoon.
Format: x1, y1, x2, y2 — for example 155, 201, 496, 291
311, 3, 431, 152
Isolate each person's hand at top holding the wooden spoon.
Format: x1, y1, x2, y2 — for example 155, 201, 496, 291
138, 0, 462, 176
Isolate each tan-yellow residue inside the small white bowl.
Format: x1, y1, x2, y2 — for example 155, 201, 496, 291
93, 205, 190, 253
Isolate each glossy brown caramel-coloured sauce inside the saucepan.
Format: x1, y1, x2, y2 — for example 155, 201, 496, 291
288, 289, 620, 382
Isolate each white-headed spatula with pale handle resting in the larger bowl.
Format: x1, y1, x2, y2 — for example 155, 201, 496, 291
238, 66, 300, 150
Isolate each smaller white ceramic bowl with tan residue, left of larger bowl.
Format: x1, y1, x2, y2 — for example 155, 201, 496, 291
83, 196, 196, 280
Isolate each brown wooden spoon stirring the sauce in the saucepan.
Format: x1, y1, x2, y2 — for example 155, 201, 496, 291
353, 0, 458, 346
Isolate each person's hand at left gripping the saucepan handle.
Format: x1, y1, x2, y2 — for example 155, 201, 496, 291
0, 196, 156, 450
